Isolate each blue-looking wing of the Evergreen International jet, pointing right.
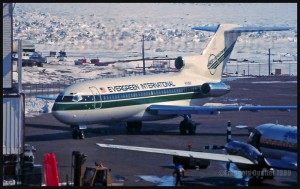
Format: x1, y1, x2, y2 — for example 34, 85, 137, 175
147, 105, 297, 115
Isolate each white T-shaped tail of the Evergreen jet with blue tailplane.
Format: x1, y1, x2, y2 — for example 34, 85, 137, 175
182, 24, 291, 82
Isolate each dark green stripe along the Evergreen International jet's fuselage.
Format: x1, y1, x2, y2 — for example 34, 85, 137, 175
52, 92, 203, 111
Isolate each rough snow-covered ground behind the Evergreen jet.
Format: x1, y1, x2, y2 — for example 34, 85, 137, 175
13, 3, 297, 116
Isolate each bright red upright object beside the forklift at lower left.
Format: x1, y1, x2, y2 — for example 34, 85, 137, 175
44, 153, 59, 186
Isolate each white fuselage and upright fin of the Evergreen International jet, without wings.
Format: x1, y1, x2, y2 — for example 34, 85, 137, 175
52, 24, 251, 125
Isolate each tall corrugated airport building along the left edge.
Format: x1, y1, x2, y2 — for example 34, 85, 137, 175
2, 3, 42, 186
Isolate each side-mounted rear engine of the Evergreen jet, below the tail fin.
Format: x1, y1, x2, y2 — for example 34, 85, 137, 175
201, 82, 230, 97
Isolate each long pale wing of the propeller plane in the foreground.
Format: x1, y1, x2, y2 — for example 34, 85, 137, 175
97, 143, 254, 164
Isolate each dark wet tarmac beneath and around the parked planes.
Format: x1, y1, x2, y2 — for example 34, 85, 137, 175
25, 76, 298, 186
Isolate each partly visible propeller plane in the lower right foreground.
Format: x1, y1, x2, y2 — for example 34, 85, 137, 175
97, 123, 298, 185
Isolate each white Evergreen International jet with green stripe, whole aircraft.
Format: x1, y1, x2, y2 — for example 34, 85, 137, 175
39, 24, 297, 139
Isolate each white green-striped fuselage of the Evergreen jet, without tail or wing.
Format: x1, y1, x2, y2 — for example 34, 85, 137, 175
52, 73, 219, 124
